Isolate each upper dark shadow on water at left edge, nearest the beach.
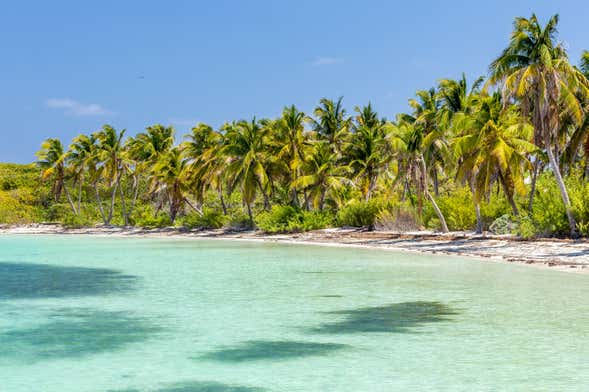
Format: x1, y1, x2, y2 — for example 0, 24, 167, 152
0, 262, 137, 300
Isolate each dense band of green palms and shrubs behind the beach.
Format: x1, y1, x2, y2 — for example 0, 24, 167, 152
0, 15, 589, 237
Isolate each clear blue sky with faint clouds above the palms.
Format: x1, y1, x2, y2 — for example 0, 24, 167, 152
0, 0, 589, 163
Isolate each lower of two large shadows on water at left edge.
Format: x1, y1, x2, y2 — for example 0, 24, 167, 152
0, 309, 160, 362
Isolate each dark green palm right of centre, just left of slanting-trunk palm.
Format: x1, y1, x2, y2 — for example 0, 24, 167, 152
345, 103, 392, 201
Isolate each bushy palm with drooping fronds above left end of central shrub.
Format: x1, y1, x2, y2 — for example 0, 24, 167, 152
221, 118, 272, 222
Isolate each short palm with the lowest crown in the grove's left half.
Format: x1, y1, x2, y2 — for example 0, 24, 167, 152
150, 147, 192, 224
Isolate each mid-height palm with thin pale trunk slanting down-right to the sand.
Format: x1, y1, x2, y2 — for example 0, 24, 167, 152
389, 120, 448, 233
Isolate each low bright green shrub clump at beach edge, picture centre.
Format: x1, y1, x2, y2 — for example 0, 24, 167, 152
256, 205, 333, 233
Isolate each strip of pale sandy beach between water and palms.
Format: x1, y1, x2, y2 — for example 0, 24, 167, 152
0, 224, 589, 273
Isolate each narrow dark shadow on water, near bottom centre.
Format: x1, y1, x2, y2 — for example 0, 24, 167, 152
199, 340, 349, 362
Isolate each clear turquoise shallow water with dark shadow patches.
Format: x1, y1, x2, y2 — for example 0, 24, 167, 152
0, 236, 589, 392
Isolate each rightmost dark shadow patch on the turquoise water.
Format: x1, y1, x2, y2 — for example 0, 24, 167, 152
311, 301, 458, 334
